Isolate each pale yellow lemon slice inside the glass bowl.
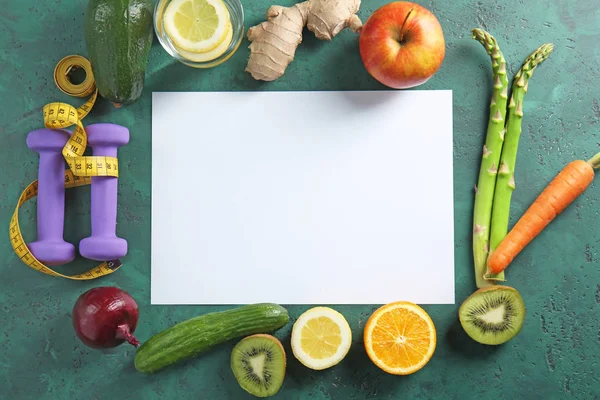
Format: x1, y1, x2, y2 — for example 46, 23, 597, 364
163, 0, 231, 53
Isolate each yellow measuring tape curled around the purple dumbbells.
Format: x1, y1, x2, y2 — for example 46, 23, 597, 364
9, 55, 121, 280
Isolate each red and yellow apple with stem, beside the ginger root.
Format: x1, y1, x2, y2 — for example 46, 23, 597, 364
360, 1, 446, 89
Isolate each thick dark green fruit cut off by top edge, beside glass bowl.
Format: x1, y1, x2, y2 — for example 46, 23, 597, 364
84, 0, 153, 107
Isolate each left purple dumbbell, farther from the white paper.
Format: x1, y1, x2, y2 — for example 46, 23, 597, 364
27, 129, 75, 266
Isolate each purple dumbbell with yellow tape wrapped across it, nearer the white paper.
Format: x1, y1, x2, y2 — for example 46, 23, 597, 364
79, 124, 129, 261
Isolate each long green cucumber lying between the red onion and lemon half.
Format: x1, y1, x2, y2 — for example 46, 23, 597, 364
135, 303, 289, 374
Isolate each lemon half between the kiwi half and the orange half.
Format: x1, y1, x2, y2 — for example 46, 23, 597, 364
292, 307, 352, 370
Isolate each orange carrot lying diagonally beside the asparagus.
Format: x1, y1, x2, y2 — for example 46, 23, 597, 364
488, 153, 600, 274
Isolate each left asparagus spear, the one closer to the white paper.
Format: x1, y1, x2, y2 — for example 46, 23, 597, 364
472, 29, 508, 288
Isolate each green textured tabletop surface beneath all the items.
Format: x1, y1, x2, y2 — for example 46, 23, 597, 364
0, 0, 600, 400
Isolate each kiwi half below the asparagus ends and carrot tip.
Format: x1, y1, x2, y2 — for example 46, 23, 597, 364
458, 286, 525, 345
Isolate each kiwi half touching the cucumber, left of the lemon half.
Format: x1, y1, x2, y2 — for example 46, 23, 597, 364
231, 334, 286, 397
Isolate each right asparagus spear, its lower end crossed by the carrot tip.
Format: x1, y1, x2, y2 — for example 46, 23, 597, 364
485, 43, 554, 280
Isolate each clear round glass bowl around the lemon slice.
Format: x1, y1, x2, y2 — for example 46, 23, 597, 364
154, 0, 244, 68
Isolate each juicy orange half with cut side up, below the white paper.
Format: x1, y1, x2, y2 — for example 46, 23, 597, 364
364, 301, 436, 375
